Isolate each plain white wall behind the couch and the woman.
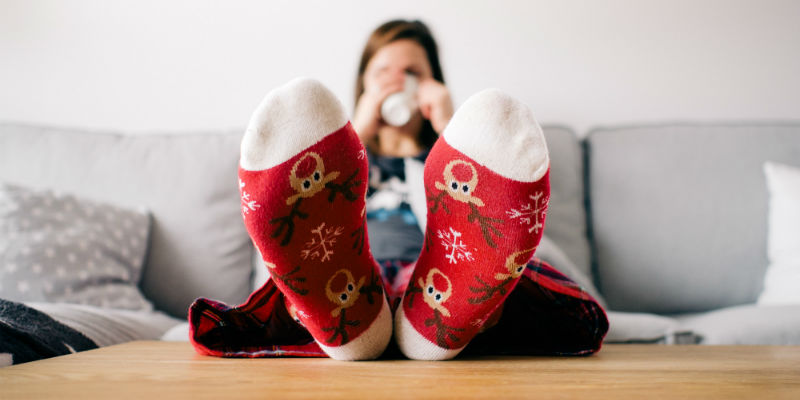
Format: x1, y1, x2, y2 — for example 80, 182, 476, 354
0, 0, 800, 133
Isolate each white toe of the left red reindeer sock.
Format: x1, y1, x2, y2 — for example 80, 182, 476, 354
239, 78, 348, 171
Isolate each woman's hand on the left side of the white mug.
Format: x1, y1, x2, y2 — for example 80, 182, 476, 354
353, 76, 404, 143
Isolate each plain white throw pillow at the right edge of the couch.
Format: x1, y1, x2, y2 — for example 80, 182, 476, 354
758, 162, 800, 304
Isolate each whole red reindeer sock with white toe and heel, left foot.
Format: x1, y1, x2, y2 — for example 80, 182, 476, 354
239, 79, 392, 360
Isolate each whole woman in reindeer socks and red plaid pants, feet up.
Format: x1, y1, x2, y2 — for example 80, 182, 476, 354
189, 21, 608, 360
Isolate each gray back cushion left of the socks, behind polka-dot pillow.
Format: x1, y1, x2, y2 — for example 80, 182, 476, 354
0, 124, 252, 316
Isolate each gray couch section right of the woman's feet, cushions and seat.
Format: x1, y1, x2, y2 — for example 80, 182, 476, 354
545, 124, 800, 344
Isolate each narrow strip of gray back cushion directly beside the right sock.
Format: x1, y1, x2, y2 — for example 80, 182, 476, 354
542, 126, 592, 277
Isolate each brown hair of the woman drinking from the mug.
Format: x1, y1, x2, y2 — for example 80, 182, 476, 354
355, 19, 444, 148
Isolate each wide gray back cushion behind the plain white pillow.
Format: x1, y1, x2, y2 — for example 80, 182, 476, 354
587, 124, 800, 313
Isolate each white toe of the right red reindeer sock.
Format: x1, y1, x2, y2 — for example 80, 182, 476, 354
443, 89, 550, 182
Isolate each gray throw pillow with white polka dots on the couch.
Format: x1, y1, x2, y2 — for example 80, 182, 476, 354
0, 184, 152, 310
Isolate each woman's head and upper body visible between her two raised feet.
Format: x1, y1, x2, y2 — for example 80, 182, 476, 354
353, 20, 453, 284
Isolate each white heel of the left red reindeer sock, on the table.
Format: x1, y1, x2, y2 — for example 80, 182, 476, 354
317, 296, 392, 361
